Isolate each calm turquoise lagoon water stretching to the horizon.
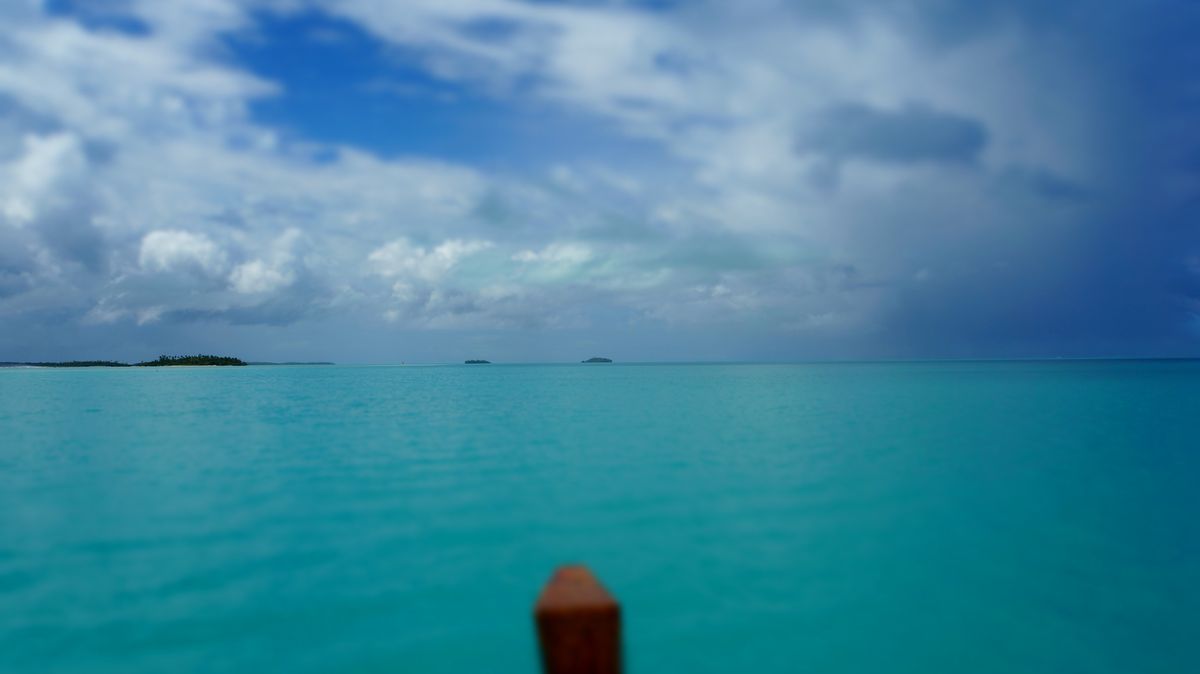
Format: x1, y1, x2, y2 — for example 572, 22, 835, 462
0, 362, 1200, 674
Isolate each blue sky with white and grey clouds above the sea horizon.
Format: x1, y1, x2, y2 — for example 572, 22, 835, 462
0, 0, 1200, 362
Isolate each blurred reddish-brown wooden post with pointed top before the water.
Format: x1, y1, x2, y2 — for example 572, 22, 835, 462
533, 566, 620, 674
